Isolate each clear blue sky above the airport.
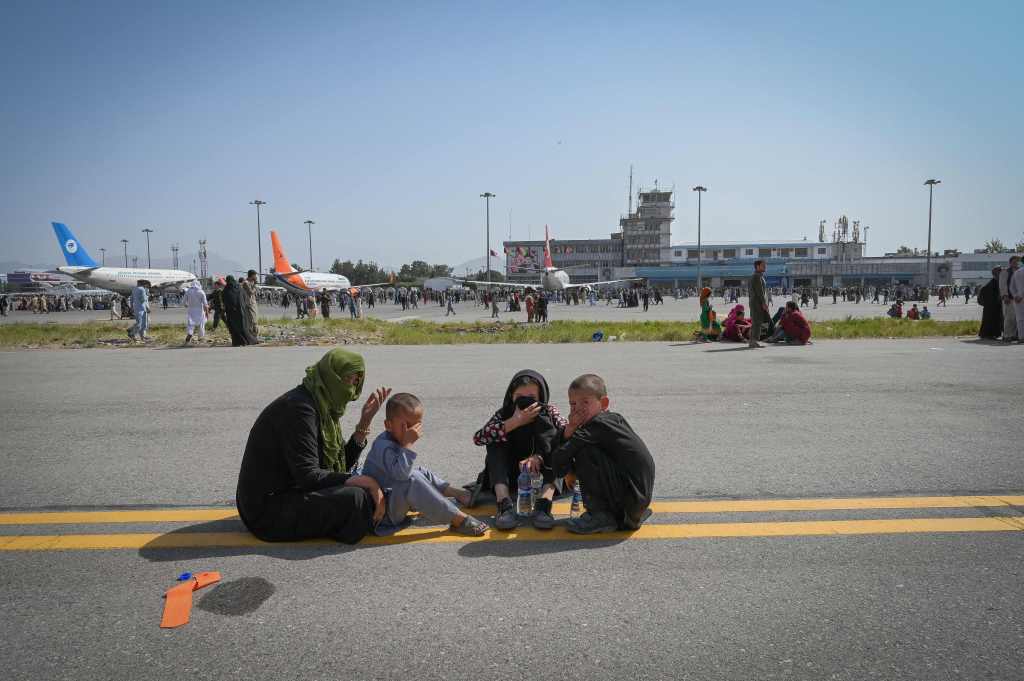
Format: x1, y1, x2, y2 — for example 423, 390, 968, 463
0, 1, 1024, 267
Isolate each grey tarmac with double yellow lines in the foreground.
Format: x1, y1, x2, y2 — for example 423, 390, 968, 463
0, 337, 1024, 679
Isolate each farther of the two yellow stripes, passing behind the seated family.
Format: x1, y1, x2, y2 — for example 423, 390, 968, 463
0, 496, 1024, 525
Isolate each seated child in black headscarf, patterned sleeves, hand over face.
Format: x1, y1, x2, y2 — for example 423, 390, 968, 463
473, 369, 566, 529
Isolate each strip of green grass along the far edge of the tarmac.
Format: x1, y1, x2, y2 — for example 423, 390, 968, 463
0, 317, 978, 348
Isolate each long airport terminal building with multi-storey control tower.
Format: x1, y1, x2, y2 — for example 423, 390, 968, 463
504, 188, 1011, 289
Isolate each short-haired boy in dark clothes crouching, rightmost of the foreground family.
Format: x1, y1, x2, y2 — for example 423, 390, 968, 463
551, 374, 654, 535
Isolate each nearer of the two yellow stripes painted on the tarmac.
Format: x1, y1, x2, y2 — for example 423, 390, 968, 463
0, 517, 1024, 551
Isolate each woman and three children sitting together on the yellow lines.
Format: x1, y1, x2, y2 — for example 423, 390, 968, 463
236, 349, 654, 544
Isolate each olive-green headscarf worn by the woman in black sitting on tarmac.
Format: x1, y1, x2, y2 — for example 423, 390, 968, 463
302, 349, 366, 473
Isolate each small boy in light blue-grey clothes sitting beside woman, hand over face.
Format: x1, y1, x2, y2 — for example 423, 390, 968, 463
361, 392, 487, 537
